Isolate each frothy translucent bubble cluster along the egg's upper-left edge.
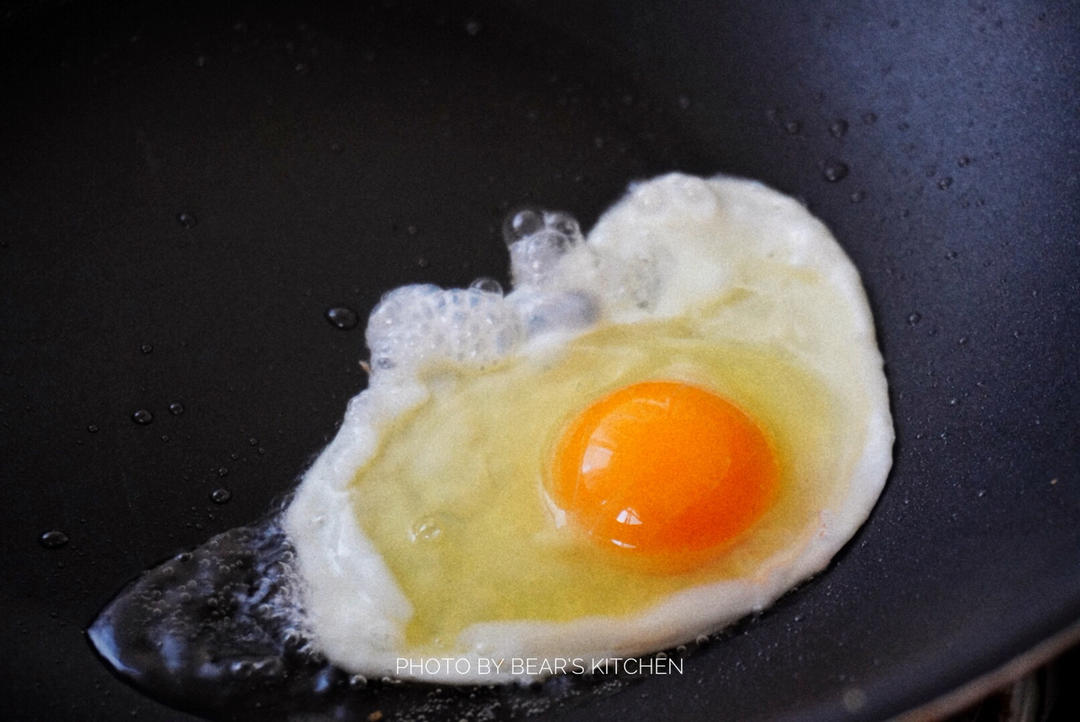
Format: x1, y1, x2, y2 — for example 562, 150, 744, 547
366, 198, 673, 383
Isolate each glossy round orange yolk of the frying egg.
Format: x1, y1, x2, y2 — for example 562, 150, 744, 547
545, 381, 779, 568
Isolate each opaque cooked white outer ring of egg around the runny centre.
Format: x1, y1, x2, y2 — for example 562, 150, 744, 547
285, 174, 893, 683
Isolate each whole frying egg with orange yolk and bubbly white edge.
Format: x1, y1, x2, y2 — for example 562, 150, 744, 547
285, 174, 893, 683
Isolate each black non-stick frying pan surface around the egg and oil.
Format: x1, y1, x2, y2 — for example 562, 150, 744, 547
0, 0, 1080, 720
